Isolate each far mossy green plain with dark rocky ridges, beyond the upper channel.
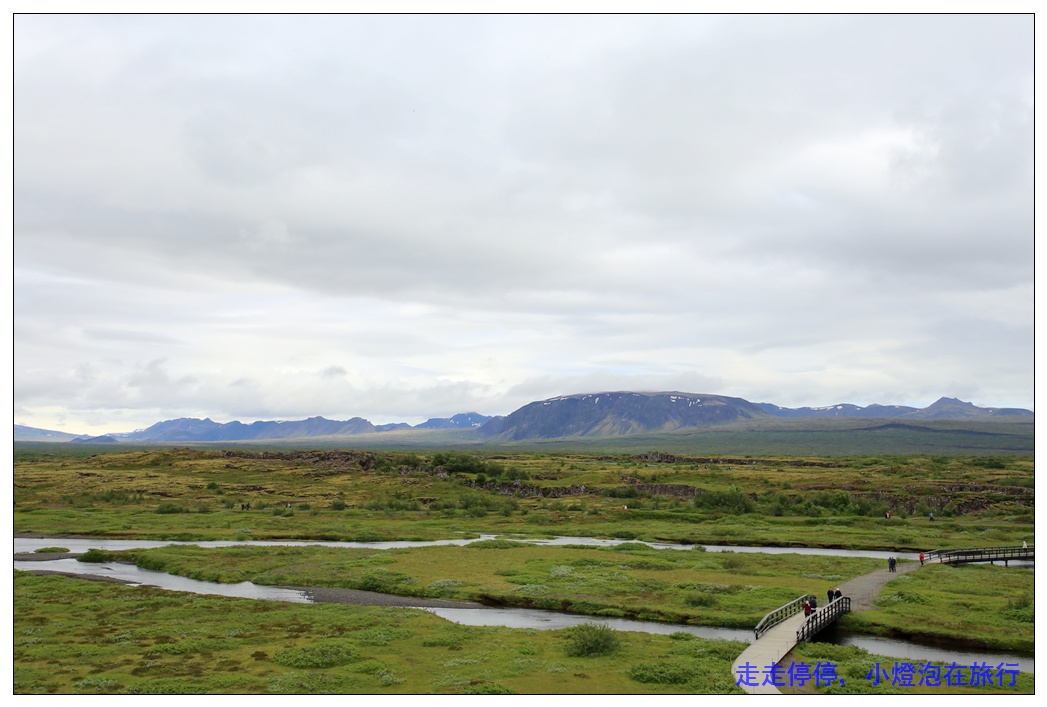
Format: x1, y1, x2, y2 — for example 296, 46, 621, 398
15, 445, 1034, 551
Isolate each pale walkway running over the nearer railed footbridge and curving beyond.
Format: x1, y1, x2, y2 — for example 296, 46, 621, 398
731, 562, 920, 694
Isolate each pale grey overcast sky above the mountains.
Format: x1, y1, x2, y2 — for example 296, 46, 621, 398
14, 15, 1033, 434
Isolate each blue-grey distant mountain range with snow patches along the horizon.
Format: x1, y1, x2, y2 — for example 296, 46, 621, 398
15, 392, 1033, 443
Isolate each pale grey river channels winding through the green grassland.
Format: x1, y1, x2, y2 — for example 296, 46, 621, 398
14, 535, 1033, 672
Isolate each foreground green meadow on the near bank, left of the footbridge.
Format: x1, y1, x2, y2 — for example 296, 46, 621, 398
14, 572, 744, 694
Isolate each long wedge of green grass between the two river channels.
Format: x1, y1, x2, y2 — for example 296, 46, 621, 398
77, 539, 883, 628
